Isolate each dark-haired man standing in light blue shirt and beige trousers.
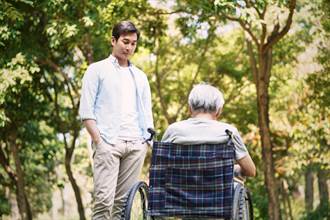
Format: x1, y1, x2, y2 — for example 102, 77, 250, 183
79, 21, 153, 220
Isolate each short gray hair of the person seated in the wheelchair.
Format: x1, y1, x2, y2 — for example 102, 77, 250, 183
188, 83, 225, 113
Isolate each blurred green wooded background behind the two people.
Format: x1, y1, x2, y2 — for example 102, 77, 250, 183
0, 0, 330, 220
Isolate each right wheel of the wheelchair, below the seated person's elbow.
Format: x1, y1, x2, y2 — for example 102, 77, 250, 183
233, 183, 253, 220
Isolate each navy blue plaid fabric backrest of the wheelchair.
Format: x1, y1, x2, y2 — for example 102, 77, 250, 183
148, 141, 235, 218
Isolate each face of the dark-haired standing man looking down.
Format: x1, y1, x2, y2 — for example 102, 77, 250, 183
111, 33, 137, 60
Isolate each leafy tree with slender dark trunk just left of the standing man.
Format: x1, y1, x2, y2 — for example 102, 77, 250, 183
0, 0, 162, 219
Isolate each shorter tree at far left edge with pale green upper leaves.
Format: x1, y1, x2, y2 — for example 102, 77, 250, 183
0, 54, 56, 219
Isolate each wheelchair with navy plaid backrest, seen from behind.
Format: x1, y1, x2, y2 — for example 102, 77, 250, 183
122, 131, 253, 220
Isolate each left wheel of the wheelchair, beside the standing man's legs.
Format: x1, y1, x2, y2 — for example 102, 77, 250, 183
122, 181, 148, 220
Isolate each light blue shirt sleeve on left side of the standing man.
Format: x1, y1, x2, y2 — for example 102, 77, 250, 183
79, 65, 99, 120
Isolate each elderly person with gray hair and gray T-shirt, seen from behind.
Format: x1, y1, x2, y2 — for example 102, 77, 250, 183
162, 84, 256, 176
